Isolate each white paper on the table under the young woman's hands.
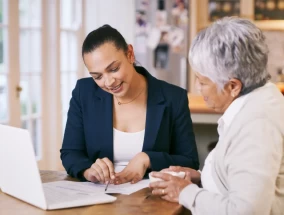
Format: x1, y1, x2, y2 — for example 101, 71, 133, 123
43, 179, 150, 195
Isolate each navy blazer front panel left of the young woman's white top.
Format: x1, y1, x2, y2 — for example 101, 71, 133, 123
93, 88, 113, 162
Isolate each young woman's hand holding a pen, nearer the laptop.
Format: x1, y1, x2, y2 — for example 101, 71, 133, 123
83, 158, 115, 184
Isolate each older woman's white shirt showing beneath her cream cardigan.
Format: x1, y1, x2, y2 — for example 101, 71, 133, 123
201, 90, 248, 193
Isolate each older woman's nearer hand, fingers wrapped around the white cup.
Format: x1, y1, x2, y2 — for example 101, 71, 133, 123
149, 172, 192, 202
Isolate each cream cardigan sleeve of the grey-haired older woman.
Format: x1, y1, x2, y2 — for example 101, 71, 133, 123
179, 118, 283, 215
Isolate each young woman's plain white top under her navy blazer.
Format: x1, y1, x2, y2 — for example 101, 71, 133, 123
113, 128, 145, 172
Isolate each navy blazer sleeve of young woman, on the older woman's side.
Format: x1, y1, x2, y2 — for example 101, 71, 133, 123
145, 90, 199, 171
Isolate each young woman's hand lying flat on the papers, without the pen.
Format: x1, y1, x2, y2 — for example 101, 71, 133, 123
114, 152, 150, 184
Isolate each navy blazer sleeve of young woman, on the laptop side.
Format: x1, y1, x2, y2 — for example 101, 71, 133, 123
60, 81, 93, 180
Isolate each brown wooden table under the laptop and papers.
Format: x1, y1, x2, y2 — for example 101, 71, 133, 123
0, 171, 191, 215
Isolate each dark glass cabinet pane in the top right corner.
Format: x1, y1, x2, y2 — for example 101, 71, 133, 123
254, 0, 284, 20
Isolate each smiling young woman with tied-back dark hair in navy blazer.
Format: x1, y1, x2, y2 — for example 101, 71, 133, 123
61, 25, 199, 184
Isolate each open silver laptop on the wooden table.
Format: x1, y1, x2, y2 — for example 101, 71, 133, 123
0, 125, 116, 210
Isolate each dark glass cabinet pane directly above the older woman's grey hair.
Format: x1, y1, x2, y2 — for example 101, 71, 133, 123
208, 0, 240, 21
